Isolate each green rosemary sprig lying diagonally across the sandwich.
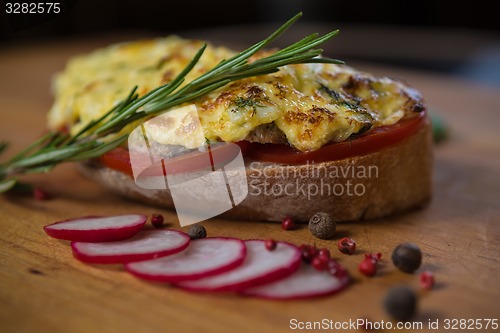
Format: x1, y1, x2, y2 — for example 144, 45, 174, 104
0, 13, 342, 192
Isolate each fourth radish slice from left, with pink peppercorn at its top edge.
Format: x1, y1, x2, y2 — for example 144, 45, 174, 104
177, 240, 301, 291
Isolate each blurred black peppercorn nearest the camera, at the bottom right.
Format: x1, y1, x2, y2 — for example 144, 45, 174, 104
384, 286, 417, 321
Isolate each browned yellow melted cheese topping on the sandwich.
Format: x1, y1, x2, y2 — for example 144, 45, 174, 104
48, 36, 424, 151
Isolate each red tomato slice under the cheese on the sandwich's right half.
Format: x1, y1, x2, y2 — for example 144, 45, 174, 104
248, 112, 427, 165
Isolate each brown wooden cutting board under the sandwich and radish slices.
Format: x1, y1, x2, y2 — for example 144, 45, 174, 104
0, 31, 500, 333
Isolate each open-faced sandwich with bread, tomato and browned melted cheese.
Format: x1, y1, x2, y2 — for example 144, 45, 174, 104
45, 36, 432, 221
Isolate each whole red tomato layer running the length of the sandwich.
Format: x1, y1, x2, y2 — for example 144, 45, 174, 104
100, 112, 428, 177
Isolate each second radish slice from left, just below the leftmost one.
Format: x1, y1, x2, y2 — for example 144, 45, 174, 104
71, 229, 191, 264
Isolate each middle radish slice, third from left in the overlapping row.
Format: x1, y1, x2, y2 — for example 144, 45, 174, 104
125, 237, 246, 283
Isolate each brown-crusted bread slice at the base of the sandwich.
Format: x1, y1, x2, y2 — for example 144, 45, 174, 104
79, 121, 433, 222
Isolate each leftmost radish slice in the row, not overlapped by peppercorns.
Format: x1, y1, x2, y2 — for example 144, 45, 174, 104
43, 214, 148, 242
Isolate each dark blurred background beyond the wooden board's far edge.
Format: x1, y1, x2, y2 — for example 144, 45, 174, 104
0, 0, 500, 85
